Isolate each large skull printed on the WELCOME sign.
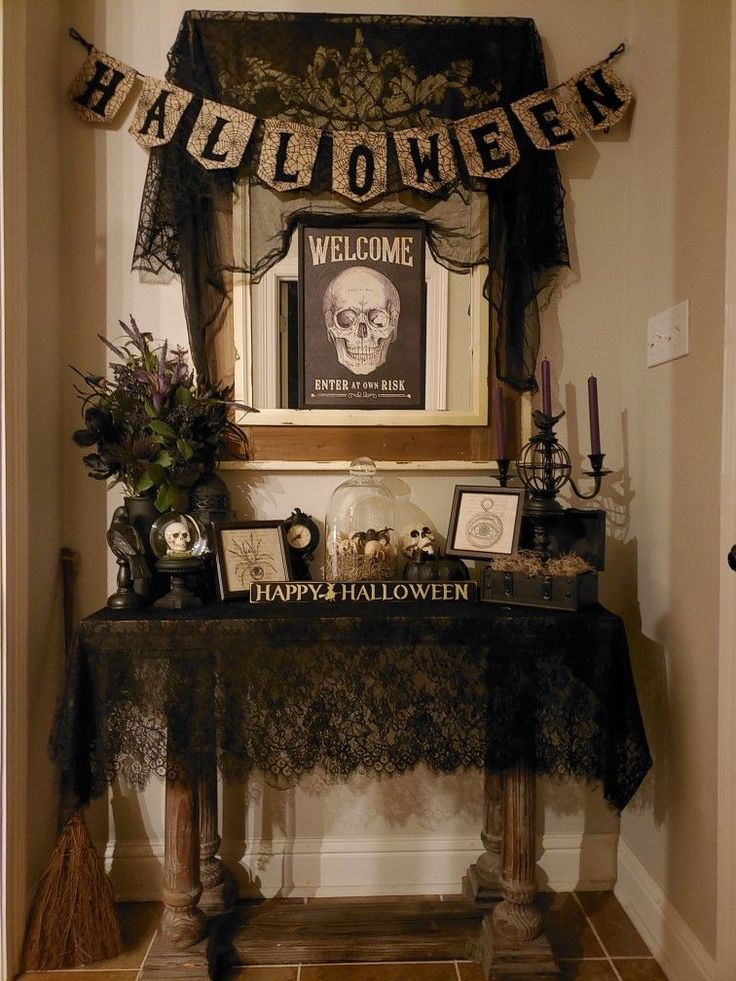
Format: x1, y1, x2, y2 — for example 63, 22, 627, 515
322, 266, 401, 375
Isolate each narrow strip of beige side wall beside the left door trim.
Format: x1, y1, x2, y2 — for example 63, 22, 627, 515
26, 0, 67, 904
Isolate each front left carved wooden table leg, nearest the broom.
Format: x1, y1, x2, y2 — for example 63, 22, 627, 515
161, 752, 207, 947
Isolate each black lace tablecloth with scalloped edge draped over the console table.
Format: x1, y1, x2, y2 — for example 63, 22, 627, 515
51, 603, 651, 809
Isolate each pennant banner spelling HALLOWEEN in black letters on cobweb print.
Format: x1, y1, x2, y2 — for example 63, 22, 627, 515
69, 29, 633, 203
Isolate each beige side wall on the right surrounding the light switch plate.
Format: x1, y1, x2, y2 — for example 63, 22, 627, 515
621, 2, 730, 954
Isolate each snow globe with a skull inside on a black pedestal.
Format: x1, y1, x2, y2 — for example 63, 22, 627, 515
150, 511, 207, 610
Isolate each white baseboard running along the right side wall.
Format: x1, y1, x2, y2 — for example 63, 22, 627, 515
614, 841, 716, 981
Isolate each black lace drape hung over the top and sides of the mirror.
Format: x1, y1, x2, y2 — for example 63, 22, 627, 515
133, 11, 568, 390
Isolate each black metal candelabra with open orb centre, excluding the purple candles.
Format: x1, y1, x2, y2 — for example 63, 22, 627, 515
512, 409, 611, 557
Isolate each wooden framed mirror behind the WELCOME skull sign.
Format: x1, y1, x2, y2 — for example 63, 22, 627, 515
231, 198, 521, 469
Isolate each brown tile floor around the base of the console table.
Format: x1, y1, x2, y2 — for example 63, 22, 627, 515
17, 892, 666, 981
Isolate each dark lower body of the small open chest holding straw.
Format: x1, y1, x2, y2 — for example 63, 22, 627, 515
480, 565, 598, 610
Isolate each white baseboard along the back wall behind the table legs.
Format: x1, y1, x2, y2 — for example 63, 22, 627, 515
100, 834, 617, 902
